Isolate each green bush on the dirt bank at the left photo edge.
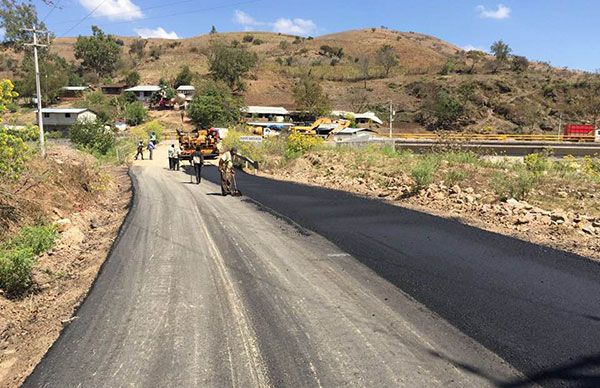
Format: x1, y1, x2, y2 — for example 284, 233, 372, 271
0, 226, 57, 296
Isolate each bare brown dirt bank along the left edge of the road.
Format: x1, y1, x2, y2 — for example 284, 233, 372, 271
0, 146, 131, 387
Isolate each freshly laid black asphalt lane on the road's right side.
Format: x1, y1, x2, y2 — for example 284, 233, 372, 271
202, 170, 600, 387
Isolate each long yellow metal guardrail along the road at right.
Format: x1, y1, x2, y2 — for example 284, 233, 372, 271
381, 133, 595, 143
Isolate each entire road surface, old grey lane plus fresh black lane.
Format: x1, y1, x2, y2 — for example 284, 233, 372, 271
25, 147, 600, 387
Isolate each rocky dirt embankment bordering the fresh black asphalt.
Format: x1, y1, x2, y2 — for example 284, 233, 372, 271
263, 151, 600, 260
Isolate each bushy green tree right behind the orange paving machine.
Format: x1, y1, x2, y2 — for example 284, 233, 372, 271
188, 81, 242, 128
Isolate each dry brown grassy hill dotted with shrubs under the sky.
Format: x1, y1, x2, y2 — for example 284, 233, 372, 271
0, 29, 600, 133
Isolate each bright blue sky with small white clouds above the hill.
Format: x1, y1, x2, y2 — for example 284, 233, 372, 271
27, 0, 600, 71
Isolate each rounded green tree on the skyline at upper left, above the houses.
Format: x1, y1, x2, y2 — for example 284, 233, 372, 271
75, 26, 121, 77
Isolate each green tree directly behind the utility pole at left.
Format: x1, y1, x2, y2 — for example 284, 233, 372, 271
18, 54, 69, 103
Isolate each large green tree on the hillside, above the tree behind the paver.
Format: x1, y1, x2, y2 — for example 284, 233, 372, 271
209, 43, 258, 93
